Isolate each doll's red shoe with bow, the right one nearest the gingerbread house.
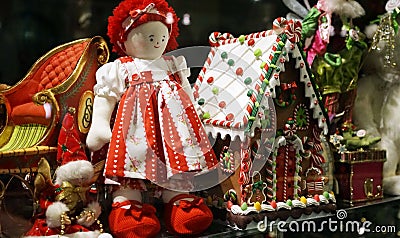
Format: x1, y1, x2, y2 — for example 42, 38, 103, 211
164, 194, 213, 235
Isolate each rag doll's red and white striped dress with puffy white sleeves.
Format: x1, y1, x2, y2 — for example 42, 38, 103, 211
94, 56, 218, 187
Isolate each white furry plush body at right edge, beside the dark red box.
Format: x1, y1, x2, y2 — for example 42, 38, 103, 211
354, 26, 400, 195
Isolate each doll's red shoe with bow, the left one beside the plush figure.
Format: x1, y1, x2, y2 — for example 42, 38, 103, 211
108, 200, 160, 238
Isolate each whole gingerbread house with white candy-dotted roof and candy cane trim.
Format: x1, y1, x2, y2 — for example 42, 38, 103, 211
194, 18, 334, 228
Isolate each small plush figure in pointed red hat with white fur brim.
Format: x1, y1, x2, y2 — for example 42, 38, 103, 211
23, 108, 112, 238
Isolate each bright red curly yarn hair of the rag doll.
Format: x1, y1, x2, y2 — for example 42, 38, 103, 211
107, 0, 179, 56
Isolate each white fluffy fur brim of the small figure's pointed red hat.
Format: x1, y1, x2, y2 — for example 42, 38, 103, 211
55, 160, 94, 185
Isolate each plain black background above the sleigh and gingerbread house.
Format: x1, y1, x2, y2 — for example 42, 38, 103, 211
0, 0, 386, 85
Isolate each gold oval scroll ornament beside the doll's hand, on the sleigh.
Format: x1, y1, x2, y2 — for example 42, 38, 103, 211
77, 90, 94, 134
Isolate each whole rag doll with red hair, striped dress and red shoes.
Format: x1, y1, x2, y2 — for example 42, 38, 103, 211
86, 0, 218, 237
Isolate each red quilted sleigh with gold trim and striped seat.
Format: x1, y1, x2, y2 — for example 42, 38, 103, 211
0, 36, 109, 231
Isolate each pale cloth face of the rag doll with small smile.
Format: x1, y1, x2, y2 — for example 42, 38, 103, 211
125, 21, 169, 60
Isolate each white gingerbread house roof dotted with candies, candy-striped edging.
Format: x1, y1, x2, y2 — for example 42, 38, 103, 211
193, 18, 328, 141
